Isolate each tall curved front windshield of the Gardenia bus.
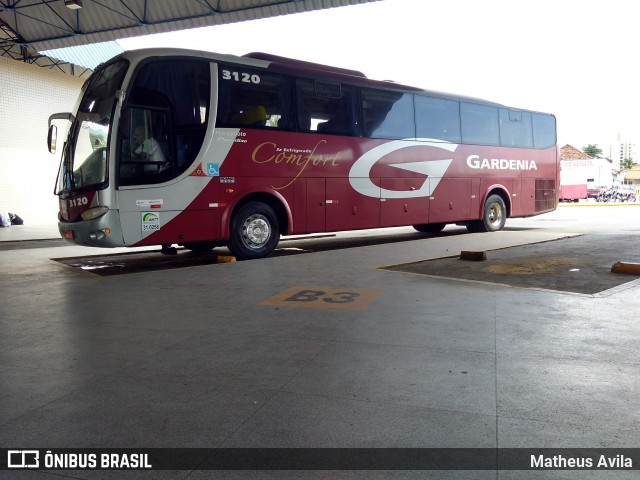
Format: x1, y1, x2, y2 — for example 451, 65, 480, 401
57, 61, 128, 193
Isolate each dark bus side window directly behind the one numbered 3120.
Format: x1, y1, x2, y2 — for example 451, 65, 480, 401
296, 79, 359, 136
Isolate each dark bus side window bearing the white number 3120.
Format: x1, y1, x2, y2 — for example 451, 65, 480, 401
216, 65, 293, 130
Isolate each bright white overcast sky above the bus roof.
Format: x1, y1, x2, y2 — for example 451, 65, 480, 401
118, 0, 640, 155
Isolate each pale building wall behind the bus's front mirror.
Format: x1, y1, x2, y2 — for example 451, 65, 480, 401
0, 57, 83, 225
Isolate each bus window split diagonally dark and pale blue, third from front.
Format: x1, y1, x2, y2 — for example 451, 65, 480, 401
362, 89, 415, 139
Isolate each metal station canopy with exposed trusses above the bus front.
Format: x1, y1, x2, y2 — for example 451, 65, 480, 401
0, 0, 378, 76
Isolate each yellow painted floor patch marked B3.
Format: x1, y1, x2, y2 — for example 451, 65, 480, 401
260, 285, 382, 310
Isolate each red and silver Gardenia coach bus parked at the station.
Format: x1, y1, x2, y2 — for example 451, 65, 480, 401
48, 49, 559, 259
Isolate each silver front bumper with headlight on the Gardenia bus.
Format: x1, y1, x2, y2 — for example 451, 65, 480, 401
58, 210, 125, 248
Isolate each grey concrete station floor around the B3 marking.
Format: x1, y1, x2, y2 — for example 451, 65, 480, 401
0, 207, 640, 480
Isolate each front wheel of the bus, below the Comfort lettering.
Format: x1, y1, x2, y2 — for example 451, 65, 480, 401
227, 202, 280, 260
